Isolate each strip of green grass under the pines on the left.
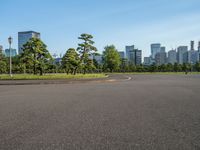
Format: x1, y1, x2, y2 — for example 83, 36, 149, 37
0, 74, 107, 80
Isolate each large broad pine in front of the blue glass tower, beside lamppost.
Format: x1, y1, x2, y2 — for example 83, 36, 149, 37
21, 38, 52, 75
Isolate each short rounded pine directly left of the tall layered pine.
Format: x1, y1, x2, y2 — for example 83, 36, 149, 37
62, 48, 80, 74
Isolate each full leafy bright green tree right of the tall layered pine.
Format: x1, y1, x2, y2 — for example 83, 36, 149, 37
103, 45, 121, 72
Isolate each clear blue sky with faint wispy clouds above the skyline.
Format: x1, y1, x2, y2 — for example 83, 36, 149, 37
0, 0, 200, 57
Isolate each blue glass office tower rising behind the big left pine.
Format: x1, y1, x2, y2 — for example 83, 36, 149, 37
18, 31, 40, 54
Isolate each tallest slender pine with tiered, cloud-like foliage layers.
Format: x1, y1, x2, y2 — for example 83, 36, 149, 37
74, 33, 97, 74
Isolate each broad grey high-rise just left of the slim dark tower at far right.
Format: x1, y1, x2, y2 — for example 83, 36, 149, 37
177, 46, 188, 64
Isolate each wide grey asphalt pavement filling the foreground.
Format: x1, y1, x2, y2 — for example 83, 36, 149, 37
0, 75, 200, 150
